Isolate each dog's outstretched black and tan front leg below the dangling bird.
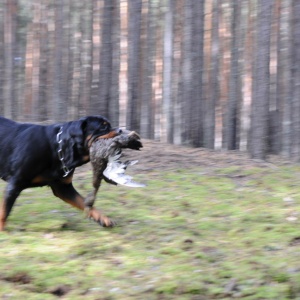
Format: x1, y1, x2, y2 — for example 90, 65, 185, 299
50, 182, 115, 227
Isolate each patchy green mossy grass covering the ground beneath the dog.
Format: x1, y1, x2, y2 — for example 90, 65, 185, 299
0, 166, 300, 300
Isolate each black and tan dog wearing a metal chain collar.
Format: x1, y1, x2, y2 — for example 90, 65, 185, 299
0, 116, 128, 230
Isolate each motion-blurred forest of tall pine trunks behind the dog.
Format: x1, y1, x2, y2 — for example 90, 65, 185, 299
0, 0, 300, 160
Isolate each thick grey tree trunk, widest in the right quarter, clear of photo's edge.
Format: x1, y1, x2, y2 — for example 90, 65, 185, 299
250, 0, 273, 159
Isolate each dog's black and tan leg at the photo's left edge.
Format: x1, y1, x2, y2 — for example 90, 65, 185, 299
0, 181, 23, 231
